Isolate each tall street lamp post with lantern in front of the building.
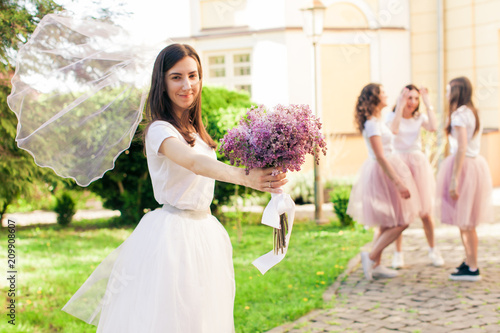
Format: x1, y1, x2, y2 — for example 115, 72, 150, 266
302, 0, 326, 223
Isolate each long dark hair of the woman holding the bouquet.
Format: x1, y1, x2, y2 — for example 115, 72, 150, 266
145, 44, 217, 149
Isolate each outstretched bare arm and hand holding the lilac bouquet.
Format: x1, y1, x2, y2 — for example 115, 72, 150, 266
158, 137, 288, 193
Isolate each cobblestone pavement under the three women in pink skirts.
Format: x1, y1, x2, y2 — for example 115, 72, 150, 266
268, 209, 500, 333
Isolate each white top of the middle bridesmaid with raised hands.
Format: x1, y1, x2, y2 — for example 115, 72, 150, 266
386, 112, 429, 153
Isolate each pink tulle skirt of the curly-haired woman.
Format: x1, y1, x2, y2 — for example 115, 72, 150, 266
347, 155, 420, 227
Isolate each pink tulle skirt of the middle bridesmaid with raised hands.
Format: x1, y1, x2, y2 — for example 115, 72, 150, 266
398, 150, 436, 217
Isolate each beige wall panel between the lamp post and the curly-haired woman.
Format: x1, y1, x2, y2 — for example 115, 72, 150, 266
319, 44, 370, 183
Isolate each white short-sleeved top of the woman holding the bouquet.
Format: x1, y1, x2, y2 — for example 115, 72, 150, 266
146, 120, 217, 211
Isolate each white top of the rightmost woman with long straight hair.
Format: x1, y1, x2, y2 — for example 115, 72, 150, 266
448, 105, 482, 157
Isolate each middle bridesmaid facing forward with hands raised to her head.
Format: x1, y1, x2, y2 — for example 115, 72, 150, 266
386, 84, 444, 268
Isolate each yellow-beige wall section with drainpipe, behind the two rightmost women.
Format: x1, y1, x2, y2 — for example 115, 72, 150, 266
410, 0, 500, 186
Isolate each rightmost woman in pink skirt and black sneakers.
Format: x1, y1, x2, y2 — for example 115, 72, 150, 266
437, 77, 493, 281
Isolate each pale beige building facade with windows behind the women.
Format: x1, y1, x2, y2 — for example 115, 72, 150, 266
166, 0, 500, 186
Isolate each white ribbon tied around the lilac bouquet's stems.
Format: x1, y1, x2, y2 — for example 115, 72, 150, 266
253, 193, 295, 274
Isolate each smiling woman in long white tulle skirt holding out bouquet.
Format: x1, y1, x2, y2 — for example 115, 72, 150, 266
63, 44, 287, 333
